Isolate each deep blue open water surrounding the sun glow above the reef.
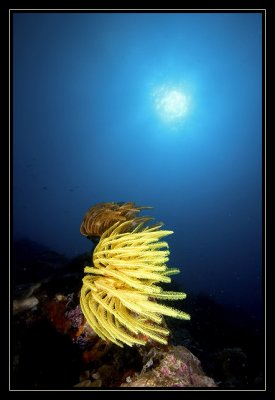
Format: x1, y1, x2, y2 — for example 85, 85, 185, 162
13, 12, 262, 314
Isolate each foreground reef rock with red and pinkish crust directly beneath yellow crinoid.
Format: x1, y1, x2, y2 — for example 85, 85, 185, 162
12, 283, 215, 390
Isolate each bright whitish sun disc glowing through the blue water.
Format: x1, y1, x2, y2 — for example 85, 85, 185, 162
153, 85, 188, 122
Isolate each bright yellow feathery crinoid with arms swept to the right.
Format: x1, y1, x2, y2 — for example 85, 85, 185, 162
80, 218, 190, 347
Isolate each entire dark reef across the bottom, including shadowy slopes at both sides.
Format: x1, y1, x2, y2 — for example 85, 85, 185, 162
11, 244, 265, 390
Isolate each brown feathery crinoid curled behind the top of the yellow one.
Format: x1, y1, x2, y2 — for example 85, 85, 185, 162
80, 202, 151, 238
